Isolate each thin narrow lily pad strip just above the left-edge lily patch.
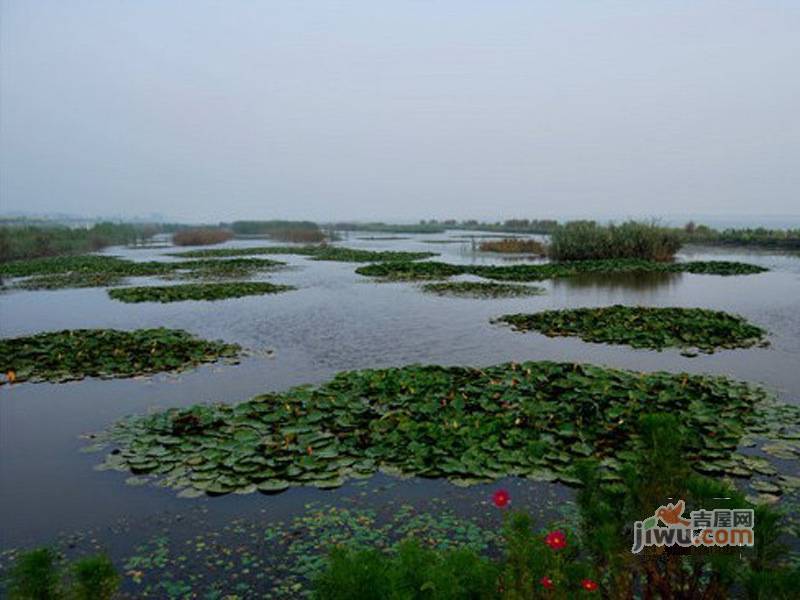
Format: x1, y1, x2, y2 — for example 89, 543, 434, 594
108, 281, 296, 302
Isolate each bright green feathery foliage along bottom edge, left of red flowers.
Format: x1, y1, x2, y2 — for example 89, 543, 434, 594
314, 540, 497, 600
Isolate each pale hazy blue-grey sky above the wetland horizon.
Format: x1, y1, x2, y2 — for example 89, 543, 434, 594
0, 0, 800, 222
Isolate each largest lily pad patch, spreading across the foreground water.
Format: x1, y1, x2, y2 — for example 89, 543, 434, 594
90, 362, 800, 497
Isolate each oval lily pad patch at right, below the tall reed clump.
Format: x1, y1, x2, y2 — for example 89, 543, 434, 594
497, 304, 767, 354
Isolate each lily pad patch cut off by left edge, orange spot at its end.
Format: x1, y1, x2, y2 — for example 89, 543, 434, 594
0, 328, 240, 383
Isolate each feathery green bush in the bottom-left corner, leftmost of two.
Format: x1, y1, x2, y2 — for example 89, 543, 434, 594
6, 548, 64, 600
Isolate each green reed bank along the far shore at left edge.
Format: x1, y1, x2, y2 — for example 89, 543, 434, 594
0, 223, 158, 263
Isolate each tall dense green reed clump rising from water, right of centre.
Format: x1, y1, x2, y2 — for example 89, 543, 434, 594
549, 221, 681, 261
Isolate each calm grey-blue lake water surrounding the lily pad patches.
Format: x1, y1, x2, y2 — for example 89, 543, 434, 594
0, 232, 800, 568
